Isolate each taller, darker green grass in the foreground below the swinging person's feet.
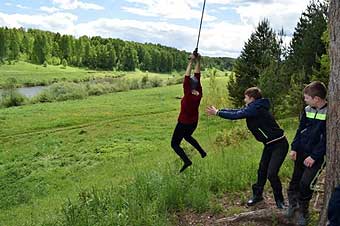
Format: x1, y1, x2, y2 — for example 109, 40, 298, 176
37, 133, 298, 226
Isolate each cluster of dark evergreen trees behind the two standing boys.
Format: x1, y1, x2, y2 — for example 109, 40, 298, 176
227, 0, 330, 115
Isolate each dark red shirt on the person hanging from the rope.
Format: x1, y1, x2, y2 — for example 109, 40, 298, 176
178, 73, 202, 124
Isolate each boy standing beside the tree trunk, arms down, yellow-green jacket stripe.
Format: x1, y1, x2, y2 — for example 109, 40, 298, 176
287, 81, 327, 226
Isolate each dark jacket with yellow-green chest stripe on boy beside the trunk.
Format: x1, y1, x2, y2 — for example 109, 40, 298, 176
292, 104, 327, 160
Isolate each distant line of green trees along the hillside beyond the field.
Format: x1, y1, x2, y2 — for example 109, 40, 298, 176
0, 27, 233, 73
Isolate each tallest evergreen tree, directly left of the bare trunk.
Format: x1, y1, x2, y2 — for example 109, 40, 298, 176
285, 0, 328, 114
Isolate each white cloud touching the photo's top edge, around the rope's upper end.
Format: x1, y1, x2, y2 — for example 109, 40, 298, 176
122, 0, 216, 21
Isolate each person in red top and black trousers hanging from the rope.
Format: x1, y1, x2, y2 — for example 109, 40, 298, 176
171, 53, 207, 172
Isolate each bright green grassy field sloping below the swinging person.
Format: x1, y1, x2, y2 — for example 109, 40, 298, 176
0, 73, 296, 226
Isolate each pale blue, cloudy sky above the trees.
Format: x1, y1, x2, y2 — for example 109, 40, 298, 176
0, 0, 309, 57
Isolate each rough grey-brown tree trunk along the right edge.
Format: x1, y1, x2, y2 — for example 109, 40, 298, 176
319, 0, 340, 226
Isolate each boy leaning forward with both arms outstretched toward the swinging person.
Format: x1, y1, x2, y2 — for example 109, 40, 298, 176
206, 87, 289, 209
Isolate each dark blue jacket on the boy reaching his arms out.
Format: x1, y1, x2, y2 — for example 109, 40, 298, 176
217, 98, 283, 144
